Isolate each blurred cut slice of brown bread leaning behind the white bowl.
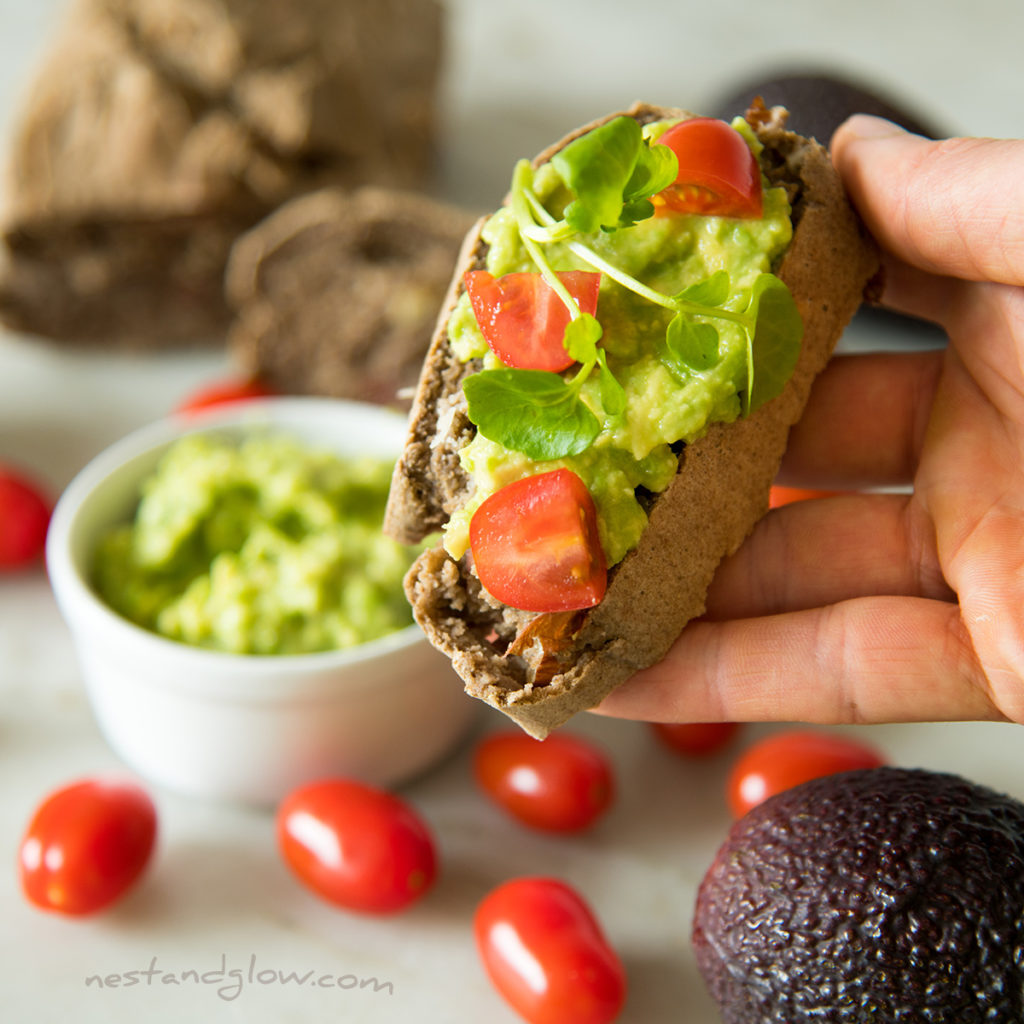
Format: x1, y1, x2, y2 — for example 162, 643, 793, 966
226, 185, 473, 403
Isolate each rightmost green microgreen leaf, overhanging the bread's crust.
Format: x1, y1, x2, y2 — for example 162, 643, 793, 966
744, 273, 804, 416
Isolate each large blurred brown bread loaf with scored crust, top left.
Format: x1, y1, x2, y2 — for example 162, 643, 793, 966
0, 0, 442, 346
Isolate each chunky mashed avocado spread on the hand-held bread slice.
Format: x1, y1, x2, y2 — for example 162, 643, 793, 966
444, 119, 800, 565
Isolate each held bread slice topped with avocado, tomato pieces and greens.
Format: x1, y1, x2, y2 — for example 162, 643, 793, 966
385, 104, 877, 738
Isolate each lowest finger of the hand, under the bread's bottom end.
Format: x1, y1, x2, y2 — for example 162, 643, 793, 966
596, 596, 1006, 724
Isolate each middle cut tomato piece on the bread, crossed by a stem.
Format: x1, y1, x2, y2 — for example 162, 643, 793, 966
463, 270, 601, 373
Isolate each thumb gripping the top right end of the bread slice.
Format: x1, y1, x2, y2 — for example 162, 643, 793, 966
831, 114, 1024, 285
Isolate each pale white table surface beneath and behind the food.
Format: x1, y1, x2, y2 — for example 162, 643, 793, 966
6, 0, 1024, 1024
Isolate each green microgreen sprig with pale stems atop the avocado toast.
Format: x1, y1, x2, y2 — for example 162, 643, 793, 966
463, 117, 803, 461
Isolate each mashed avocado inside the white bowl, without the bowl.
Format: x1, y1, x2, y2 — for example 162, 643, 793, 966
92, 432, 416, 654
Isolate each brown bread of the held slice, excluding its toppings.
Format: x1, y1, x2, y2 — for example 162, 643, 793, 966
385, 103, 878, 738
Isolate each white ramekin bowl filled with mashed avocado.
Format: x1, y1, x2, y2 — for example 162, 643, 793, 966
46, 397, 478, 806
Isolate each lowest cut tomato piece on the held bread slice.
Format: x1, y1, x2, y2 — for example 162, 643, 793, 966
469, 469, 607, 611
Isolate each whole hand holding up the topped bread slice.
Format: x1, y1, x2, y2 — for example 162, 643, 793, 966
600, 116, 1024, 723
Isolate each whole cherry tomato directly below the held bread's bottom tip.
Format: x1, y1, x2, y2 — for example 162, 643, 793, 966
473, 731, 614, 833
